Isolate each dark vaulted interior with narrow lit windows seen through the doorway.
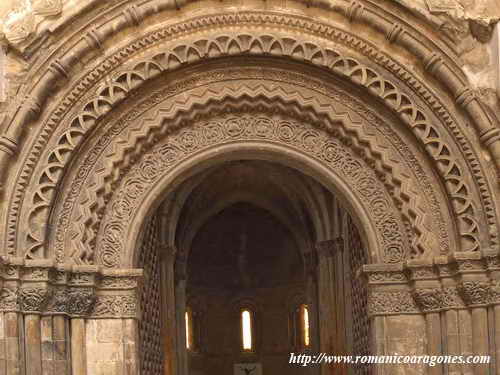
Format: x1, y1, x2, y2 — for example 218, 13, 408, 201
136, 158, 376, 374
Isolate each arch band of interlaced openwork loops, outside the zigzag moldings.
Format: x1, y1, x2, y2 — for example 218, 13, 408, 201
17, 29, 480, 258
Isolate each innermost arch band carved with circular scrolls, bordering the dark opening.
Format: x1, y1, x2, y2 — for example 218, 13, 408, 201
96, 111, 406, 267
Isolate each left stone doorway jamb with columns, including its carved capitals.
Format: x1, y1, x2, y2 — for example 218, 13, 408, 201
0, 257, 142, 375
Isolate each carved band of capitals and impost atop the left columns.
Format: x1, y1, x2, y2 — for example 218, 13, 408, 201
0, 257, 142, 318
